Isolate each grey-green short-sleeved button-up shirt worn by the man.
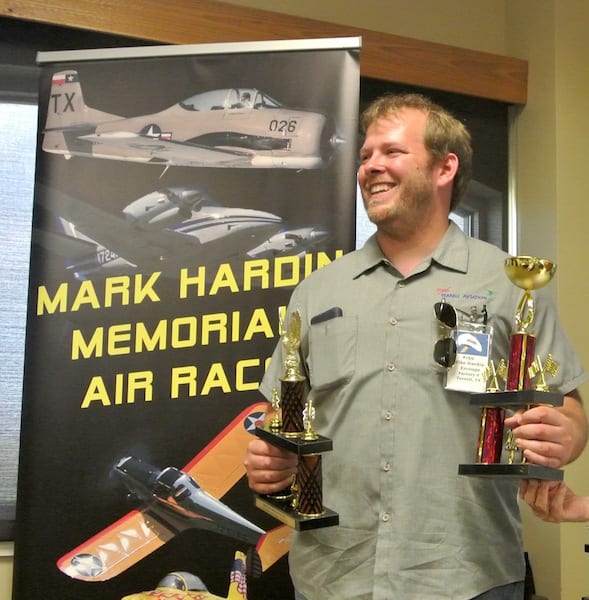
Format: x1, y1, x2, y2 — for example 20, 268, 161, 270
260, 223, 585, 600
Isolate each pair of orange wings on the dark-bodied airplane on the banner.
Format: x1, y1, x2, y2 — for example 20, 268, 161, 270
57, 402, 276, 581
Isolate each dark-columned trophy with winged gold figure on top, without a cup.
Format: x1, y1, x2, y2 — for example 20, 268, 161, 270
255, 311, 339, 531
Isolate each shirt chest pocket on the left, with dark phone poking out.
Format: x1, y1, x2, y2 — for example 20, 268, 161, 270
307, 317, 358, 390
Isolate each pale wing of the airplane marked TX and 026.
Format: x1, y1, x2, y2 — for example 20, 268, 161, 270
78, 131, 254, 167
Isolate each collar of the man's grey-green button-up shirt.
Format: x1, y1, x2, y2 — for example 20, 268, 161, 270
353, 221, 468, 279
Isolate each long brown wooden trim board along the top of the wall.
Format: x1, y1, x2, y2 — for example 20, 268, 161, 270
0, 0, 528, 104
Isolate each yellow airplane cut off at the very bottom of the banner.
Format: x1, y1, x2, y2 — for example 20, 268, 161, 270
122, 551, 247, 600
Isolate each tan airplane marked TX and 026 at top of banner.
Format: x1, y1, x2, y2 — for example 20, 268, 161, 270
43, 70, 342, 169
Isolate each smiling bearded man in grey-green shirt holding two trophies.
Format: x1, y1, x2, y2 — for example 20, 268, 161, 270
245, 94, 587, 600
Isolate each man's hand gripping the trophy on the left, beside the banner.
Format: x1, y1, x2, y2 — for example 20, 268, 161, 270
243, 439, 298, 494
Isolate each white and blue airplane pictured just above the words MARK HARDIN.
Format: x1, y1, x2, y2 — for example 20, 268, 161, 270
35, 184, 283, 279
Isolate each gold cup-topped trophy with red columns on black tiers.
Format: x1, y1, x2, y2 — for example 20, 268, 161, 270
458, 256, 563, 480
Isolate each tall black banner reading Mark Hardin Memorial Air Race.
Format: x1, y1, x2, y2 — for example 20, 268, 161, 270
13, 38, 360, 600
